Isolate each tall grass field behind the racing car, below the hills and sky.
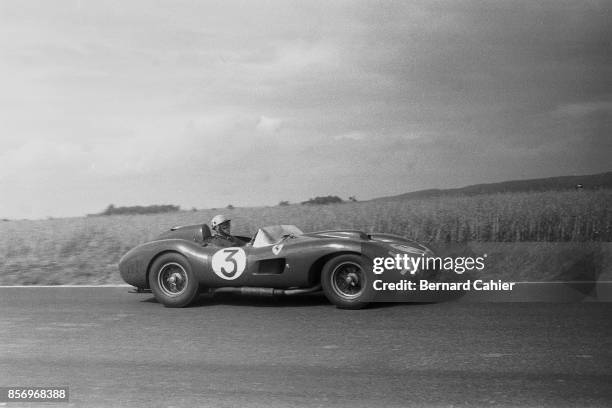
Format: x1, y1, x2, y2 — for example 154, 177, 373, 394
0, 190, 612, 285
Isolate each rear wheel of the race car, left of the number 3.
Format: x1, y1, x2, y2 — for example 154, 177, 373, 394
149, 253, 200, 307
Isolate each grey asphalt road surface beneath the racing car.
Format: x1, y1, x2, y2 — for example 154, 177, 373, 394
0, 288, 612, 407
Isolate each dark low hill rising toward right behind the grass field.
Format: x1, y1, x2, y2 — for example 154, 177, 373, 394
375, 172, 612, 200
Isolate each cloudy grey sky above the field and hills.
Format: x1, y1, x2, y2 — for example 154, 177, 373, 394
0, 0, 612, 219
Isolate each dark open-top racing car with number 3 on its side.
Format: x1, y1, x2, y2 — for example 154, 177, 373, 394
119, 224, 432, 309
